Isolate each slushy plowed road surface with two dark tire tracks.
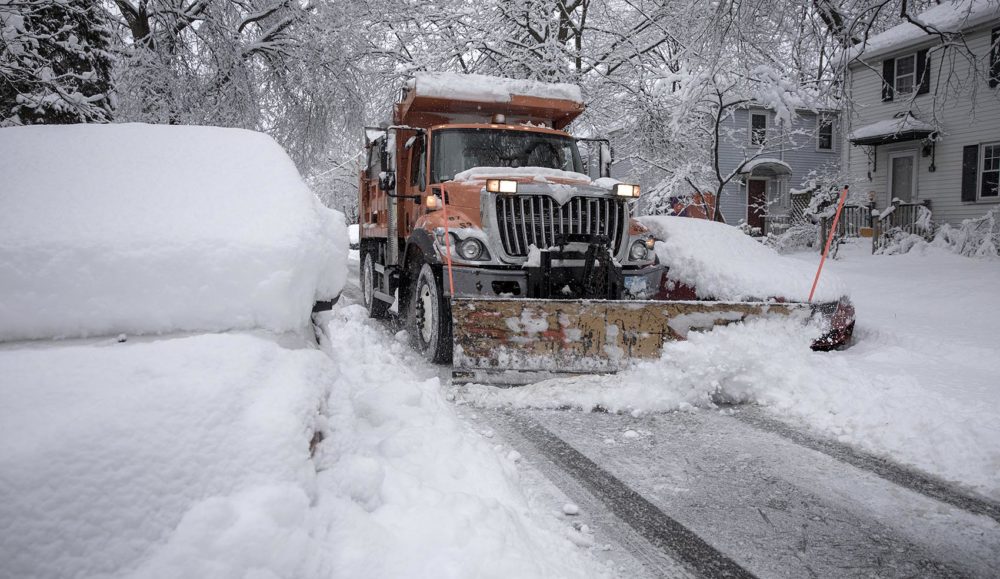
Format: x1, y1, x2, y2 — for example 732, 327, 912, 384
344, 262, 1000, 577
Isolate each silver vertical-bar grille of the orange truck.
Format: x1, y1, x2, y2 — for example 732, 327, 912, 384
496, 195, 628, 256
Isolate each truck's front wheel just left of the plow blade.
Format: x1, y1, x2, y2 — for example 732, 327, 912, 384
408, 263, 452, 364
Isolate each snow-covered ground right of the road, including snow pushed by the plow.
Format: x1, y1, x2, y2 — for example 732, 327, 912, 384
459, 243, 1000, 498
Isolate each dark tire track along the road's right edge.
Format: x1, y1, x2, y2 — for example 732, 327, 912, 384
733, 409, 1000, 523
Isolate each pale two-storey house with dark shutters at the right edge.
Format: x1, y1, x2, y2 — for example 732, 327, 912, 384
843, 0, 1000, 224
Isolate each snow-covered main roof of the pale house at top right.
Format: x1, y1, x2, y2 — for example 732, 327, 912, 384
847, 0, 1000, 60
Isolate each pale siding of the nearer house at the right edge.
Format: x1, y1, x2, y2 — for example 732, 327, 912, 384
844, 21, 1000, 225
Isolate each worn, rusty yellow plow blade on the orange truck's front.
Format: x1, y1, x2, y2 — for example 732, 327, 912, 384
451, 299, 812, 385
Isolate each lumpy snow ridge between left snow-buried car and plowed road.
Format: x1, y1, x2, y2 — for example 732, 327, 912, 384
316, 305, 605, 579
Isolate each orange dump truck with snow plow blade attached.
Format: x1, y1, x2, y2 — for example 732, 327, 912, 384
359, 73, 852, 385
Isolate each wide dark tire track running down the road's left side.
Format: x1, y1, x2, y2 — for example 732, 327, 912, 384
500, 414, 755, 578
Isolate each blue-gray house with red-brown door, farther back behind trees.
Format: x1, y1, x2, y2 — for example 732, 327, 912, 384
719, 103, 843, 234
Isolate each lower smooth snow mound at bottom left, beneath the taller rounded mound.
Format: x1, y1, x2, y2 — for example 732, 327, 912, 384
0, 334, 335, 579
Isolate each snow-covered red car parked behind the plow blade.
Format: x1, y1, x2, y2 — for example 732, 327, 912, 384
640, 216, 854, 350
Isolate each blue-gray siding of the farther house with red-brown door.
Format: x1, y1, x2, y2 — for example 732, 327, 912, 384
719, 108, 843, 225
